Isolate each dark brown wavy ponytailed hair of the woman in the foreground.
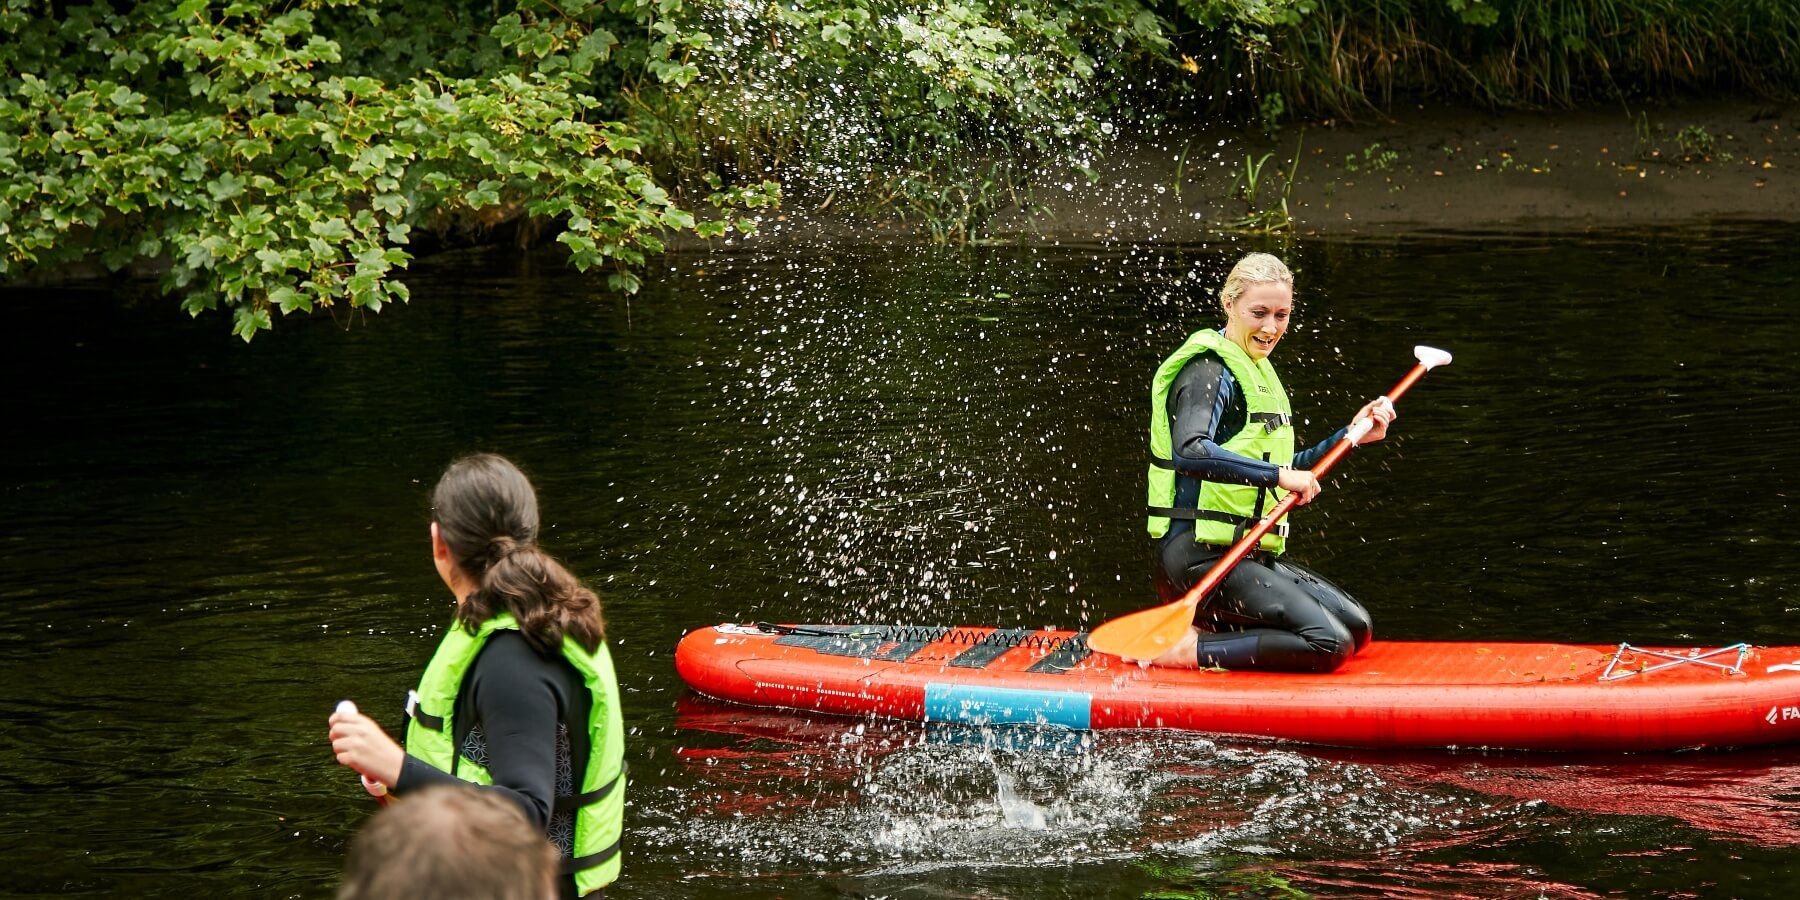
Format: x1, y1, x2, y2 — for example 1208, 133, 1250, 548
432, 454, 607, 655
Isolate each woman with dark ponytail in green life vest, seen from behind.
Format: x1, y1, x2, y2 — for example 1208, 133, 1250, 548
331, 454, 625, 896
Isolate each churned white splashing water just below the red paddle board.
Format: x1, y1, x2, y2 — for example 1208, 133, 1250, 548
641, 715, 1525, 875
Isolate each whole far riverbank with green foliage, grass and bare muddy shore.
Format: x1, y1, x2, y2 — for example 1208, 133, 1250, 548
0, 0, 1800, 340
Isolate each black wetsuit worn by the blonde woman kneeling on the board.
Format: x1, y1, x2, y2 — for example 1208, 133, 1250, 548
1156, 353, 1373, 671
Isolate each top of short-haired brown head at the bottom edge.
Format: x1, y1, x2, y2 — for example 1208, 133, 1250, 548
338, 787, 558, 900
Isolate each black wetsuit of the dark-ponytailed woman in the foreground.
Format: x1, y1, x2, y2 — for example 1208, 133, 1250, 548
394, 630, 594, 896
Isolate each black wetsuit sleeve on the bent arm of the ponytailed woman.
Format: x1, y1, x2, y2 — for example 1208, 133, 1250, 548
394, 632, 562, 828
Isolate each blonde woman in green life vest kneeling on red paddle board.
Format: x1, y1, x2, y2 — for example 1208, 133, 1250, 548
1150, 254, 1393, 671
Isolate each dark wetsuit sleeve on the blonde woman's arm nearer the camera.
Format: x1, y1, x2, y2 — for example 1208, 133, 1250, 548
1168, 353, 1282, 488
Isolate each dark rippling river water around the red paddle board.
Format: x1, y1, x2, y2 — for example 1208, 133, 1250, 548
0, 227, 1800, 898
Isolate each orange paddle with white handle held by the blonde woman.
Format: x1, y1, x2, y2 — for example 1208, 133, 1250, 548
1087, 346, 1451, 661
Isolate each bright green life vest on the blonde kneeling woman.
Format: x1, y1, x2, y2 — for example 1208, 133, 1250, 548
1150, 329, 1294, 553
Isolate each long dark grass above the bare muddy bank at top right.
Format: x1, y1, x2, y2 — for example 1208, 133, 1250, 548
1177, 0, 1800, 117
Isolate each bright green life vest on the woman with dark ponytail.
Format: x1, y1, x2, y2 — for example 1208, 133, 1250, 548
407, 612, 625, 895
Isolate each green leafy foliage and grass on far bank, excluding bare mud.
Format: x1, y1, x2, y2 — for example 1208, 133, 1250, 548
10, 0, 1800, 338
